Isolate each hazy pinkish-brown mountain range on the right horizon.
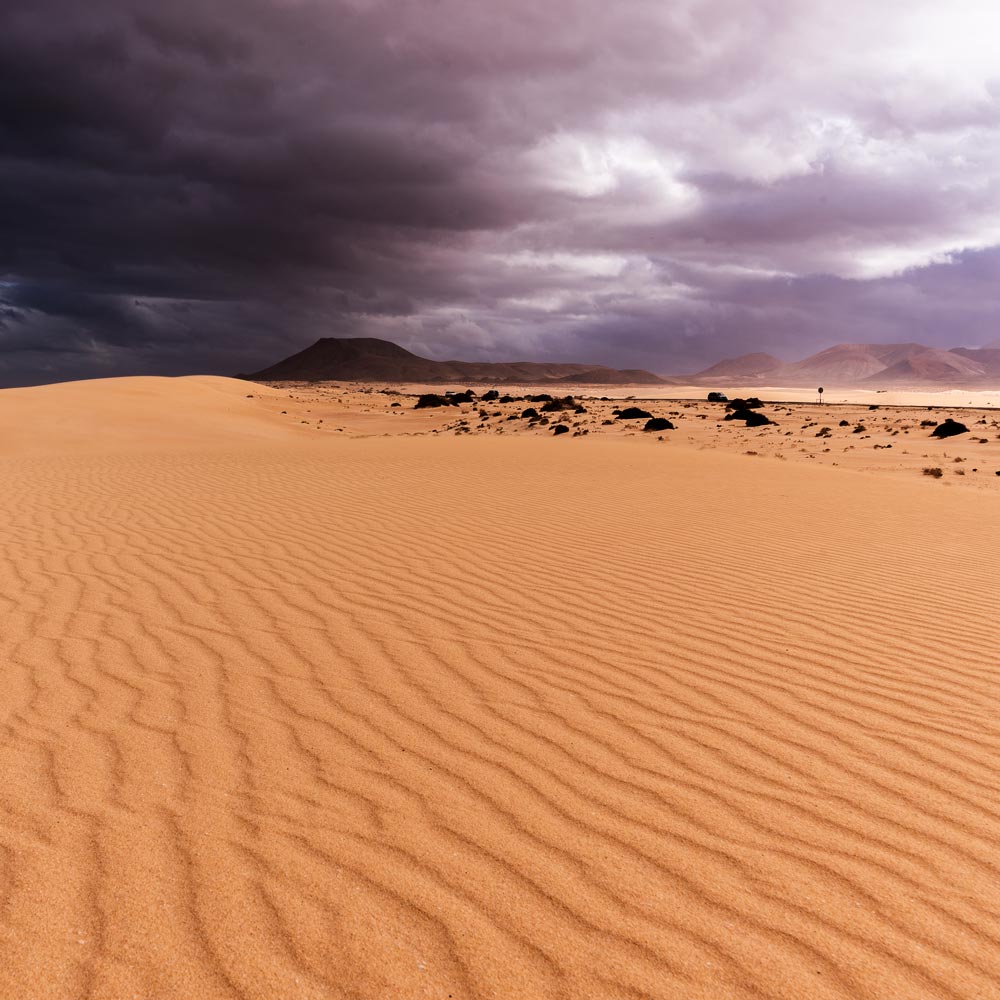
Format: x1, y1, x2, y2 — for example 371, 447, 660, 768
691, 344, 1000, 387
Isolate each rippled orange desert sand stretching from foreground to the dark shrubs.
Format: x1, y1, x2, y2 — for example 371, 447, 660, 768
0, 378, 1000, 1000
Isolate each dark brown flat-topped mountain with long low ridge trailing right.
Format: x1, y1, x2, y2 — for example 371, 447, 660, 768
241, 337, 667, 385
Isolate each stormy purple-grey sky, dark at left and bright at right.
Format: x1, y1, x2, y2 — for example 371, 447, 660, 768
0, 0, 1000, 386
